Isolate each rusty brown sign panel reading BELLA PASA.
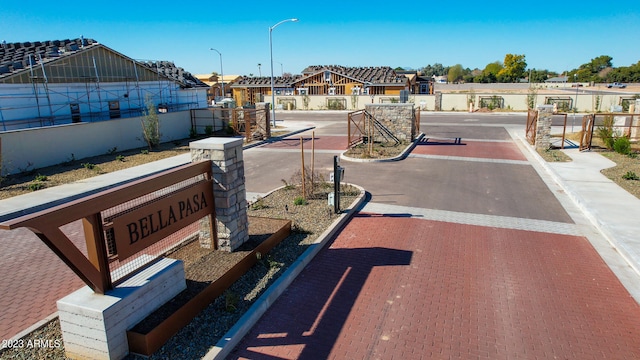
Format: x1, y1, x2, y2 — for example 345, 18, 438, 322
113, 181, 214, 261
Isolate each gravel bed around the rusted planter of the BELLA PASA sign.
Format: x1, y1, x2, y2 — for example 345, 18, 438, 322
0, 184, 360, 360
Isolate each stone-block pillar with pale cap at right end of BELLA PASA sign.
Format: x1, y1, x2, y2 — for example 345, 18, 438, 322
189, 138, 249, 251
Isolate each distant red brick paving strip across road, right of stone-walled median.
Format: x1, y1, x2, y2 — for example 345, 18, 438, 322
412, 139, 527, 160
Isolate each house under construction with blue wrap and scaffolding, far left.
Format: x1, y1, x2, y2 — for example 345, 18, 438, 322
0, 38, 208, 131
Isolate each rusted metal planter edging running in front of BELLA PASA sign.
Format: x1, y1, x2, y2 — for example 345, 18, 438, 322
127, 220, 291, 356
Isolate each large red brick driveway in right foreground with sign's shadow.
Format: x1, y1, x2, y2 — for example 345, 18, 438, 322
232, 216, 640, 359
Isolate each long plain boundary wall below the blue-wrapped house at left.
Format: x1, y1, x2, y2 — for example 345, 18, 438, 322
0, 111, 191, 175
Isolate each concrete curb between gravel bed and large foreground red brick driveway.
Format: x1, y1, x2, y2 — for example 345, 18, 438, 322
203, 184, 366, 360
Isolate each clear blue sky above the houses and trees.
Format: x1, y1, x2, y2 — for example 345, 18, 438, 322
0, 0, 640, 76
